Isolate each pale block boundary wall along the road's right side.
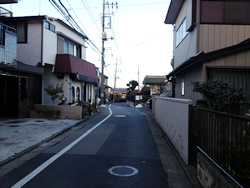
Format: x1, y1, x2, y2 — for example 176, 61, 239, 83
153, 97, 192, 164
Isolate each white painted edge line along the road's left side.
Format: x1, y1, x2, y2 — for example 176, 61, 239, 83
11, 105, 112, 188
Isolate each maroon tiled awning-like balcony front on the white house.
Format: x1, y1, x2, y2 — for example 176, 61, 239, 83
54, 54, 98, 83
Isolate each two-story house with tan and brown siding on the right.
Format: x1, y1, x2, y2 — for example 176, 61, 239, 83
165, 0, 250, 104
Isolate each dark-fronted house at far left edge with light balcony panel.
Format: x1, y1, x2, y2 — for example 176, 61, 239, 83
0, 15, 43, 118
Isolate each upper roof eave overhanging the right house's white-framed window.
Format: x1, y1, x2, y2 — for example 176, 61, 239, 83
164, 0, 185, 24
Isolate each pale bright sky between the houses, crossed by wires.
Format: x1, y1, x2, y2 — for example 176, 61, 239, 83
1, 0, 173, 88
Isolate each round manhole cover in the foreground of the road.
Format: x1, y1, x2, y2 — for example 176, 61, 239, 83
108, 165, 139, 177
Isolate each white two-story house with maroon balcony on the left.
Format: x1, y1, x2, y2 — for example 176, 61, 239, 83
0, 16, 98, 108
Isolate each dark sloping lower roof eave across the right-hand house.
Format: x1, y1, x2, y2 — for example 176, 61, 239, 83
168, 38, 250, 76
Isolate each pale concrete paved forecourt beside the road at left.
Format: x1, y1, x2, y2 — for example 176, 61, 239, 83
0, 118, 81, 164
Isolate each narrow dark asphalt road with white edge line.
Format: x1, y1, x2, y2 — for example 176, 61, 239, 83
0, 104, 168, 188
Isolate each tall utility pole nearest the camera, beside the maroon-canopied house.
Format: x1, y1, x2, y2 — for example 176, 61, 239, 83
101, 0, 105, 104
